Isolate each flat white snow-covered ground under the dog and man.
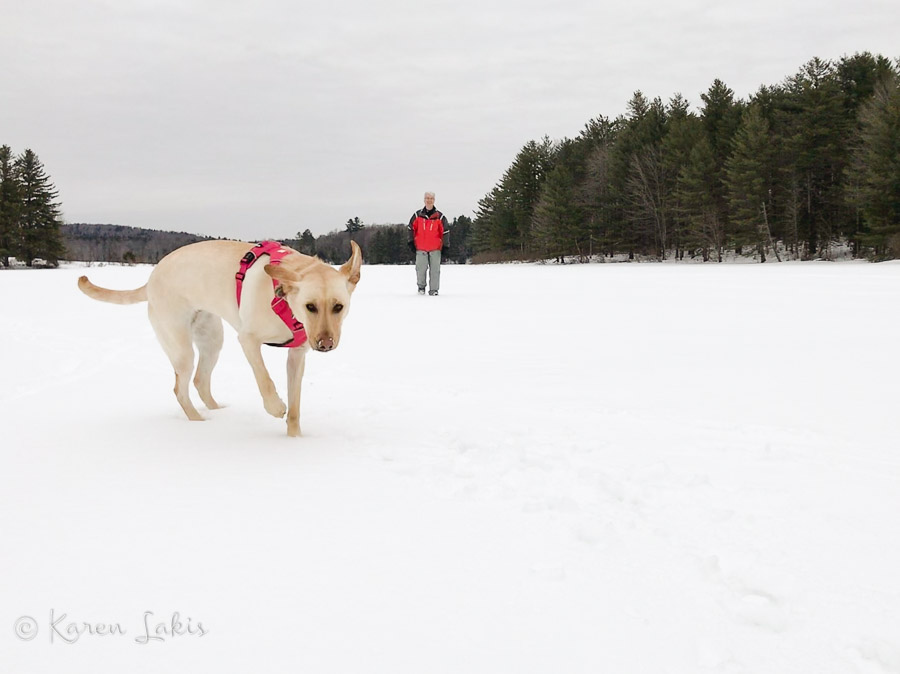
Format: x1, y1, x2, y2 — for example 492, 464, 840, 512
0, 256, 900, 674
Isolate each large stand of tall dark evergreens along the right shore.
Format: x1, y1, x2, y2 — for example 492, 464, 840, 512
471, 53, 900, 261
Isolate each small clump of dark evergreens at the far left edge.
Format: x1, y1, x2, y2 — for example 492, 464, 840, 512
0, 145, 65, 267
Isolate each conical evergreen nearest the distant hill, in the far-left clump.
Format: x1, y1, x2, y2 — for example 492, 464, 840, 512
15, 150, 65, 265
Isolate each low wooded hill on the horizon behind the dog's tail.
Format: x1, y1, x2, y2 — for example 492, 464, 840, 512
62, 223, 212, 264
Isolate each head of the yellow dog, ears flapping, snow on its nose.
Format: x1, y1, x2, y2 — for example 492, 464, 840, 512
266, 241, 362, 351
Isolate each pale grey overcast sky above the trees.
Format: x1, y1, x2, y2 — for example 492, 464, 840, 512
0, 0, 900, 239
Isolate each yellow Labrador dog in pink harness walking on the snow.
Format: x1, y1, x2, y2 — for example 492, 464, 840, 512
78, 241, 362, 436
